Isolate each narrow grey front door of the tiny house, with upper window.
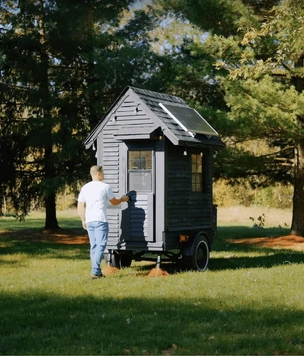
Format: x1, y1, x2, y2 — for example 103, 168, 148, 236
125, 147, 155, 242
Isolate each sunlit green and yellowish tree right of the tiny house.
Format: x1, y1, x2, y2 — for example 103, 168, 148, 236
156, 0, 304, 236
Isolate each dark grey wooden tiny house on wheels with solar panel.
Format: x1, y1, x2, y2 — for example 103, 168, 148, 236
84, 87, 224, 271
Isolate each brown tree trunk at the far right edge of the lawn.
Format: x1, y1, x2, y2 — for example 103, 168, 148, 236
291, 139, 304, 237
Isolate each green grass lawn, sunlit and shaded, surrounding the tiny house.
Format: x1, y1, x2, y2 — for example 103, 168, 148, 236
0, 210, 304, 355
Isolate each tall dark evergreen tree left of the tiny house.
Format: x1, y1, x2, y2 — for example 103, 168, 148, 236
0, 0, 164, 229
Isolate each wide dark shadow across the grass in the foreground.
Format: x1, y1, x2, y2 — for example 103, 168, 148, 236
0, 287, 304, 355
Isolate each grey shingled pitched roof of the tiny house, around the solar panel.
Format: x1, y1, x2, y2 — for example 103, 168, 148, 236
84, 86, 224, 148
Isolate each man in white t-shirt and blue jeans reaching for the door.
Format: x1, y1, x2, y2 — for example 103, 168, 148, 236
77, 166, 129, 279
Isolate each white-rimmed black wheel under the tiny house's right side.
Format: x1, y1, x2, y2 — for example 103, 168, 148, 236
183, 236, 210, 272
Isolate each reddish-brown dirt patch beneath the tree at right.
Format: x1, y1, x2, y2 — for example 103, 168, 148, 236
227, 235, 304, 251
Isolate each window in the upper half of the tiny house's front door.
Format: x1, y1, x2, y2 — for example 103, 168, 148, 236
128, 150, 152, 192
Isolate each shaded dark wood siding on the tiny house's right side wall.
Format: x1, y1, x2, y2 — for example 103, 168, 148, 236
166, 142, 212, 232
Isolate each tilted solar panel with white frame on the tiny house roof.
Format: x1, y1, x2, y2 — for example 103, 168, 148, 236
159, 103, 219, 136
